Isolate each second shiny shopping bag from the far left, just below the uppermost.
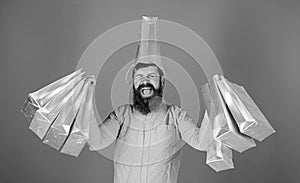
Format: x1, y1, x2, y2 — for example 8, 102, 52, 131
29, 72, 85, 139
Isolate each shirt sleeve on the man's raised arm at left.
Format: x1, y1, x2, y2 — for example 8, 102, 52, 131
87, 103, 126, 151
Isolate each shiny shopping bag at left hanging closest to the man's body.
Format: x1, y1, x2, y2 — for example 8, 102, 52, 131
61, 77, 96, 157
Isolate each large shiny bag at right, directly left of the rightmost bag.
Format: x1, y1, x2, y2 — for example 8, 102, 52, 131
208, 75, 256, 152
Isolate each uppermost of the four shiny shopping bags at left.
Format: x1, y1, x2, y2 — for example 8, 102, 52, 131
21, 69, 84, 122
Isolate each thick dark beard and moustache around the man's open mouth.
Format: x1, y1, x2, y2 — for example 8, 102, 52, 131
133, 80, 163, 115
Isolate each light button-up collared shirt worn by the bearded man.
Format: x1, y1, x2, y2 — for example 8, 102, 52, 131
88, 102, 212, 183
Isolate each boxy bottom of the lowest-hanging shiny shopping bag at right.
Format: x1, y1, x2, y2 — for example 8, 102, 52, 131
206, 140, 234, 172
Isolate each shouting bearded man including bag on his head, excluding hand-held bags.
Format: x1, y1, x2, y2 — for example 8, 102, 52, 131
88, 16, 212, 183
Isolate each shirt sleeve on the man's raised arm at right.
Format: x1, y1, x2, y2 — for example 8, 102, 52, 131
173, 106, 213, 151
